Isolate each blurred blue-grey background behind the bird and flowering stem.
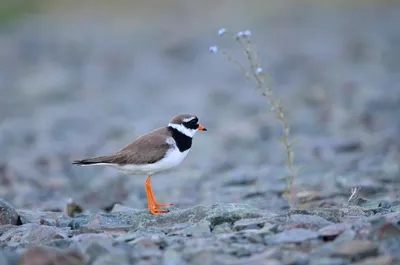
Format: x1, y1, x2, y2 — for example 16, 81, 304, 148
0, 0, 400, 211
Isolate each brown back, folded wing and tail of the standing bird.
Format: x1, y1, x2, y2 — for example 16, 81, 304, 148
73, 128, 170, 165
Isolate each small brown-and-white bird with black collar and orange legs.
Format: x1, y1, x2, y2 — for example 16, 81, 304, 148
72, 114, 207, 215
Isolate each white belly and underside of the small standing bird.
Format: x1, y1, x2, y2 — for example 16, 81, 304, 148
103, 148, 189, 175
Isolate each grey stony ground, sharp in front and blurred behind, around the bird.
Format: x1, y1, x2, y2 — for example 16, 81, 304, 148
0, 0, 400, 265
